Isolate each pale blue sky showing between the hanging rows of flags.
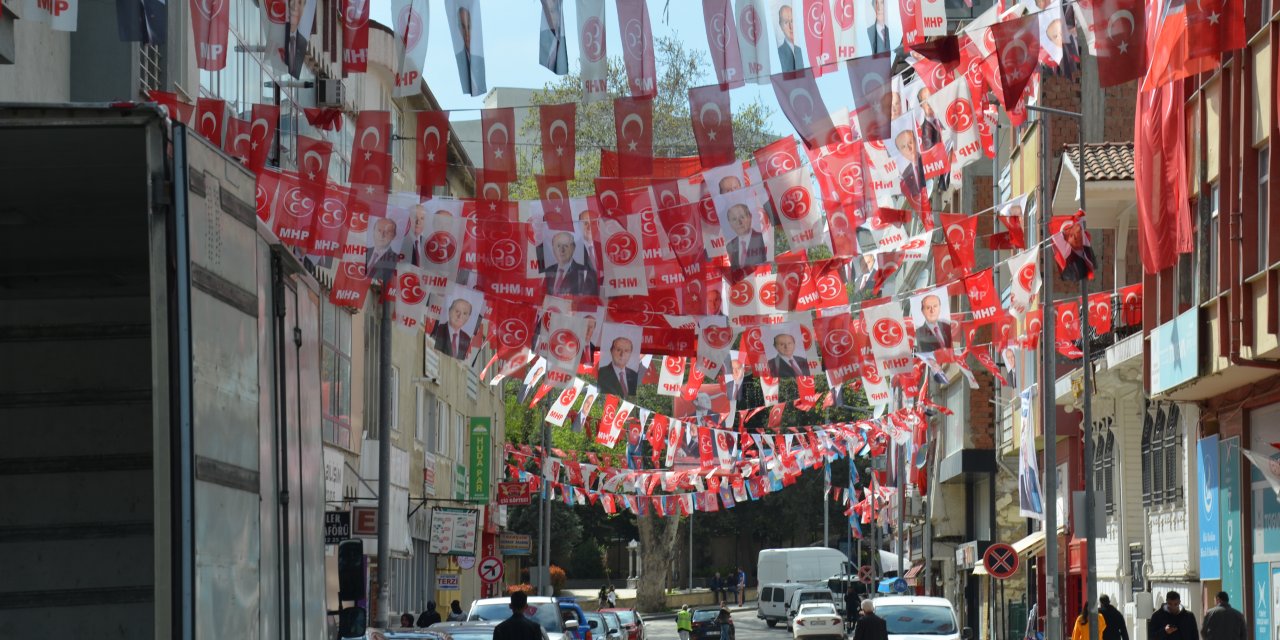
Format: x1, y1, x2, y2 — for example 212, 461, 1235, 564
370, 0, 852, 137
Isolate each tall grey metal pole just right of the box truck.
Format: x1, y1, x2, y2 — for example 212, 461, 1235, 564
369, 293, 403, 628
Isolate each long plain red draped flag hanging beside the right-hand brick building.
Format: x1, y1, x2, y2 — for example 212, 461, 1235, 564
1133, 81, 1192, 274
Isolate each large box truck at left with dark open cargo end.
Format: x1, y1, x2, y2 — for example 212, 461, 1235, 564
0, 102, 330, 640
